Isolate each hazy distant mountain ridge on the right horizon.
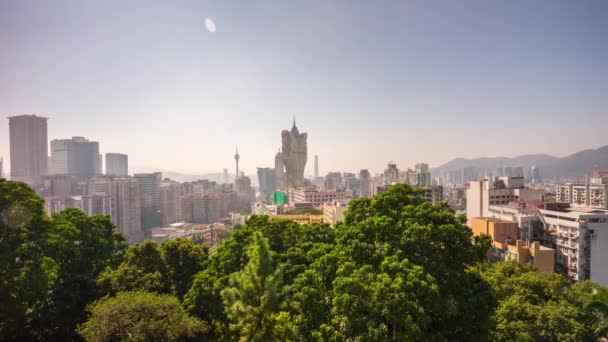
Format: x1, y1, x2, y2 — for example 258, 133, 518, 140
431, 145, 608, 178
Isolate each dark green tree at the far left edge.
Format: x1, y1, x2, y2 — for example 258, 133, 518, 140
0, 179, 53, 340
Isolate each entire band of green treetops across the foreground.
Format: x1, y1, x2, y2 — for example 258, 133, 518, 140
0, 181, 608, 341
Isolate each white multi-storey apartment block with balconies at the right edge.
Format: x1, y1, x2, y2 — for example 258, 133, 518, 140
488, 201, 608, 286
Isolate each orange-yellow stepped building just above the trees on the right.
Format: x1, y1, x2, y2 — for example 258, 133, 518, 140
471, 217, 555, 272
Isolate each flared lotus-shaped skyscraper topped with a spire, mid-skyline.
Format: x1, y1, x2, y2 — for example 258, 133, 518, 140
281, 118, 308, 188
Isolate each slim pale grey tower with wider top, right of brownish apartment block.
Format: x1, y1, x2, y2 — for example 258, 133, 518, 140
133, 172, 162, 230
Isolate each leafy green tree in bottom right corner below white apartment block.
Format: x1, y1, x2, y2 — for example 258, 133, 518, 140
480, 261, 600, 341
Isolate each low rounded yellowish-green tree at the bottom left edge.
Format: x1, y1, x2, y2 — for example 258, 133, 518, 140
78, 291, 206, 341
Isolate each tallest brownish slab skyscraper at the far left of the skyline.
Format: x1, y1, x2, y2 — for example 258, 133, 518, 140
8, 115, 49, 185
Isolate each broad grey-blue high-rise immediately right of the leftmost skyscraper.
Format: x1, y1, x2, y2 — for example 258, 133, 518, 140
50, 137, 100, 181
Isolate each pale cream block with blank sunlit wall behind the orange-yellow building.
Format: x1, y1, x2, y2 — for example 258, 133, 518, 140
467, 177, 544, 225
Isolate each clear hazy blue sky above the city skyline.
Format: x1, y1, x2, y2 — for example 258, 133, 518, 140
0, 0, 608, 174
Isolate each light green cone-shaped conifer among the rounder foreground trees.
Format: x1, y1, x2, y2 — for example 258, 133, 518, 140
222, 232, 291, 341
